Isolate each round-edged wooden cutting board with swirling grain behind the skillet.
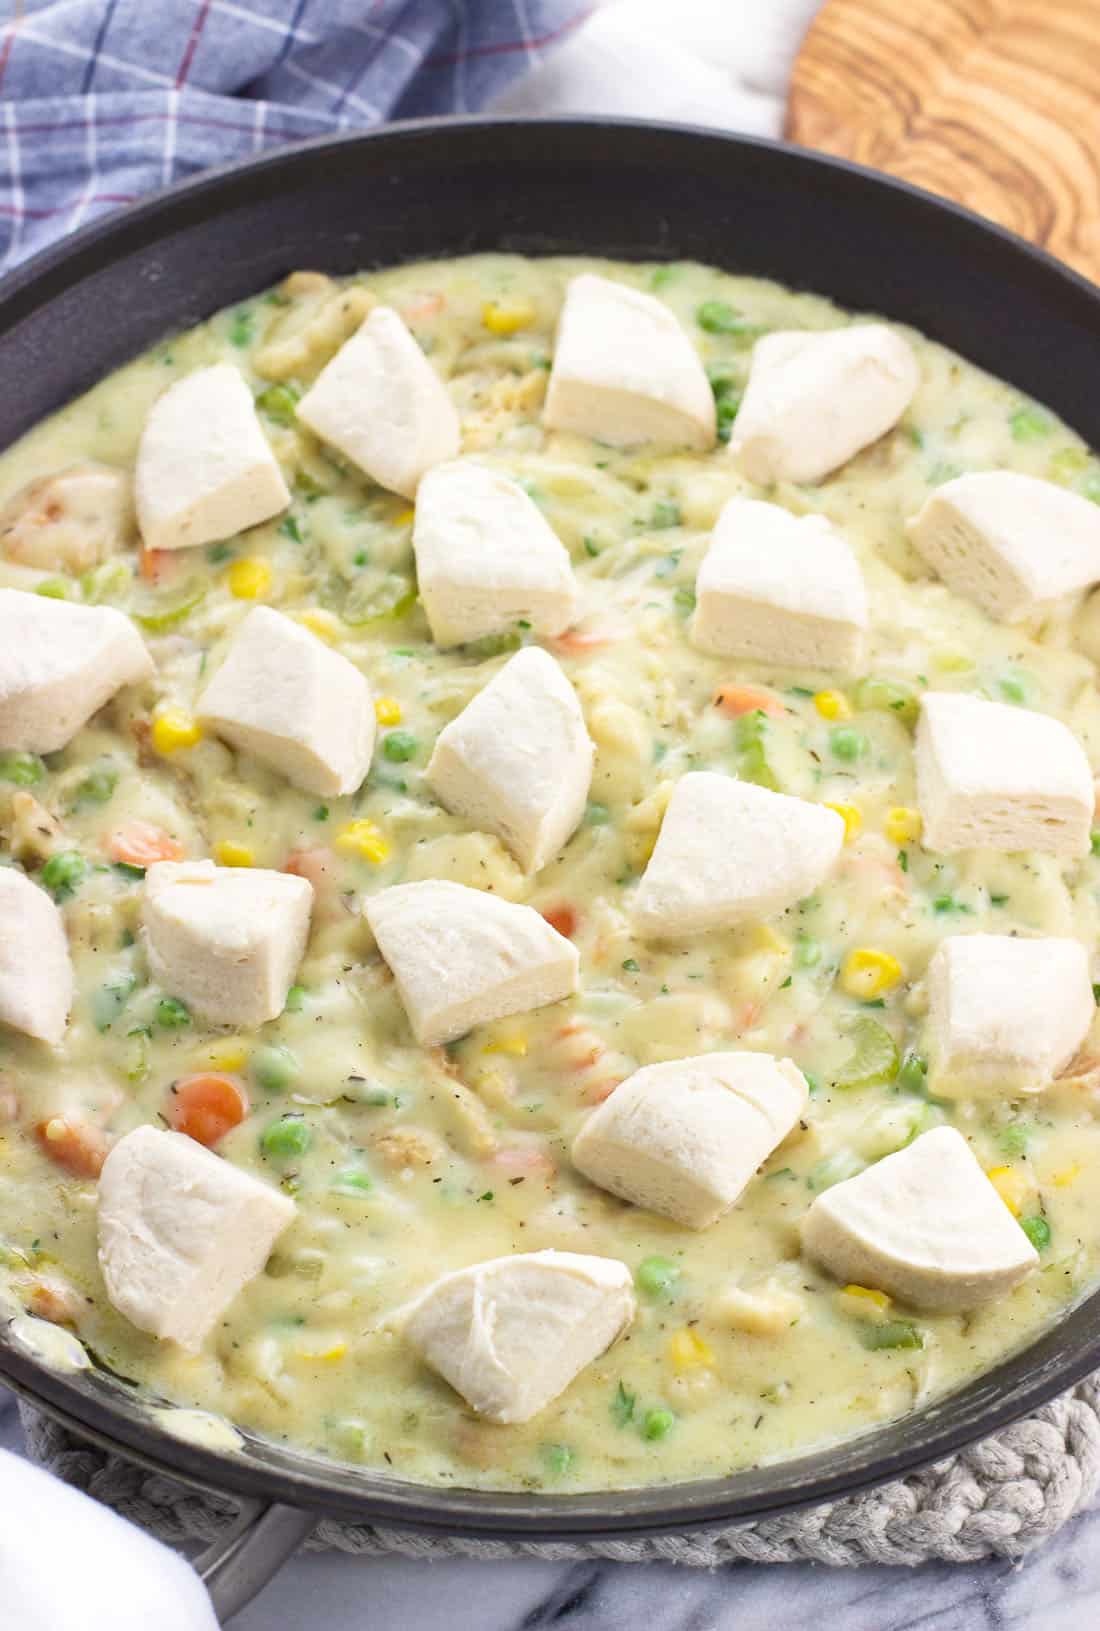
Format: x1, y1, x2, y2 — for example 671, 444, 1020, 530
787, 0, 1100, 283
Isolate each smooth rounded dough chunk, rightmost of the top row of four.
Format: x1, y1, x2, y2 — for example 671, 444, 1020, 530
730, 323, 920, 488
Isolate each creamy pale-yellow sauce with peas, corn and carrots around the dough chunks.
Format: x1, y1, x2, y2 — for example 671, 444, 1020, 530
0, 256, 1100, 1489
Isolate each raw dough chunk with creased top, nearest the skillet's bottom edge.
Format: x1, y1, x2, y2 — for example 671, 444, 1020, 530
405, 1251, 635, 1422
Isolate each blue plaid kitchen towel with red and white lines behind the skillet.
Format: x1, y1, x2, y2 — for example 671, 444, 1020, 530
0, 0, 591, 272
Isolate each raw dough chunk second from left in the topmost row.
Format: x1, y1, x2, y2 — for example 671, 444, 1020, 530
297, 307, 462, 499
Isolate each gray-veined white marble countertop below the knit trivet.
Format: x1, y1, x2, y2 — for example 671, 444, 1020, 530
0, 1391, 1100, 1631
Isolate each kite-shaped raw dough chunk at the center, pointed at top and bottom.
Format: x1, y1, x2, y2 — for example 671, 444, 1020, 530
428, 646, 594, 873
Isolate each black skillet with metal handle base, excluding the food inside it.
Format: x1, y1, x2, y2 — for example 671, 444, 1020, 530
0, 121, 1100, 1616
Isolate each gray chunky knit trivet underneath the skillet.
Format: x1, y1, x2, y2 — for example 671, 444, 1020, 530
23, 1372, 1100, 1567
